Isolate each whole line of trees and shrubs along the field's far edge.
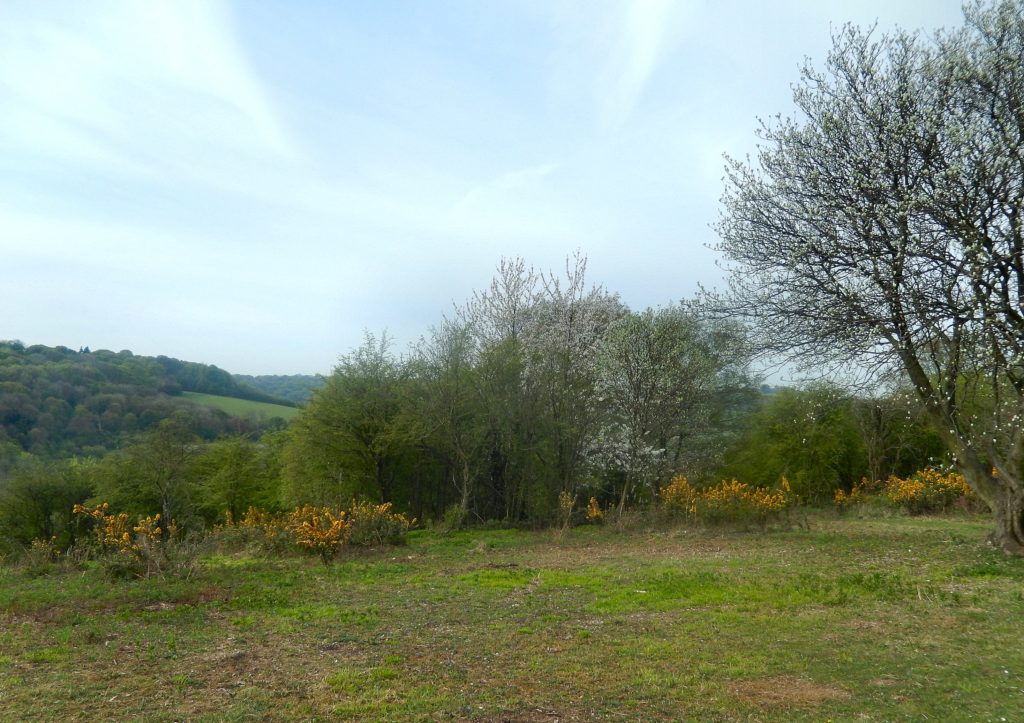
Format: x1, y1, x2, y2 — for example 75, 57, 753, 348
0, 256, 948, 549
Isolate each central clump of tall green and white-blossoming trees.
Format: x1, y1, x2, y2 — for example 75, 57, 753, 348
284, 255, 750, 524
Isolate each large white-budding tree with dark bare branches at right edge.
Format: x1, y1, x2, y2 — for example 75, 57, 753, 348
713, 0, 1024, 553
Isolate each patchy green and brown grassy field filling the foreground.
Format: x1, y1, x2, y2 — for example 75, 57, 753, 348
0, 517, 1024, 721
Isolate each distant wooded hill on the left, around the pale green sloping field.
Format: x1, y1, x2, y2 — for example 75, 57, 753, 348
0, 341, 294, 462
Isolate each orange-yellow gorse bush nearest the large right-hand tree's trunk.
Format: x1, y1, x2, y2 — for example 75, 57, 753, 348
835, 468, 975, 514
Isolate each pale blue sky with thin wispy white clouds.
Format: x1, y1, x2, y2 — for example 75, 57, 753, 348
0, 0, 963, 374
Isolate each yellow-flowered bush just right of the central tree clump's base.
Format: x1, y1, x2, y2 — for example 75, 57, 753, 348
659, 475, 796, 524
